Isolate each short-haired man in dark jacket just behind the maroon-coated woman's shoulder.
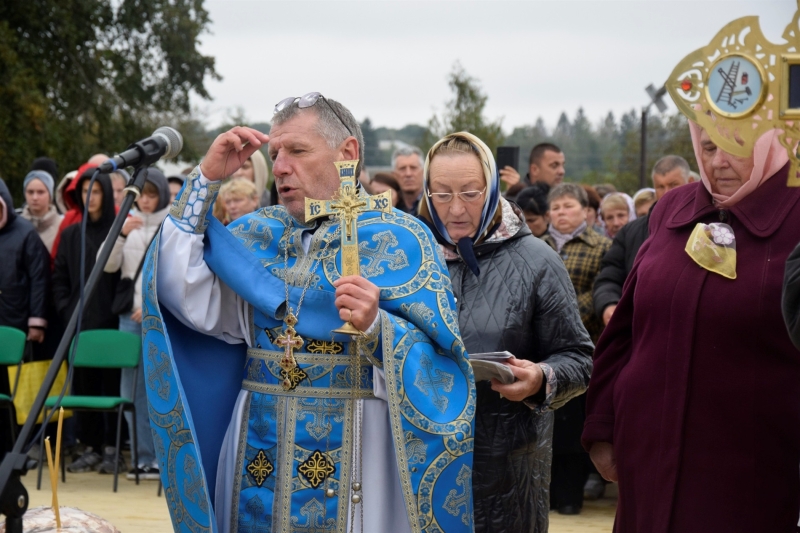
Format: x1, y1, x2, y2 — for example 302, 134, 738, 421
593, 155, 693, 324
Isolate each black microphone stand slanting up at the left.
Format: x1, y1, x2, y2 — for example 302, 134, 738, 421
0, 165, 152, 533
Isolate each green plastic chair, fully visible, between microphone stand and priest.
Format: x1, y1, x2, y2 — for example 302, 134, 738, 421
36, 329, 142, 492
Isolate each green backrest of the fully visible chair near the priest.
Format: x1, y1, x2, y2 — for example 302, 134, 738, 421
73, 329, 142, 368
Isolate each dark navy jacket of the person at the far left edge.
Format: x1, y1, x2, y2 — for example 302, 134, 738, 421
0, 179, 50, 332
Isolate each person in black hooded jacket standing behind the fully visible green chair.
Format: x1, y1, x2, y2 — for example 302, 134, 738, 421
53, 167, 120, 473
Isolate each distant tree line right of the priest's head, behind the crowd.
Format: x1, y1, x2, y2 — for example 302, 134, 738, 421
361, 64, 696, 192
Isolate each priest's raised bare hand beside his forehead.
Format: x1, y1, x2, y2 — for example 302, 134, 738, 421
200, 126, 269, 181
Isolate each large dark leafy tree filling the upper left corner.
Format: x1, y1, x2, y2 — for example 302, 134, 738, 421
0, 0, 219, 202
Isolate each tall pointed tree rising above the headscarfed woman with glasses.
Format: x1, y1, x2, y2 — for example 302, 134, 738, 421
426, 62, 505, 152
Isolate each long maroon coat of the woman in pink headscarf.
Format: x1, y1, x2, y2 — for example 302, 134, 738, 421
583, 165, 800, 533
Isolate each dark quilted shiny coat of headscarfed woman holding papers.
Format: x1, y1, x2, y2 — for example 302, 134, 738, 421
447, 217, 592, 533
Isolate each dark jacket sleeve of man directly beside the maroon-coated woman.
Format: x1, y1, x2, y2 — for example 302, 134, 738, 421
592, 214, 650, 321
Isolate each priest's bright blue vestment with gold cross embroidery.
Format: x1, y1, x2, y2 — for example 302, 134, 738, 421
143, 171, 475, 532
